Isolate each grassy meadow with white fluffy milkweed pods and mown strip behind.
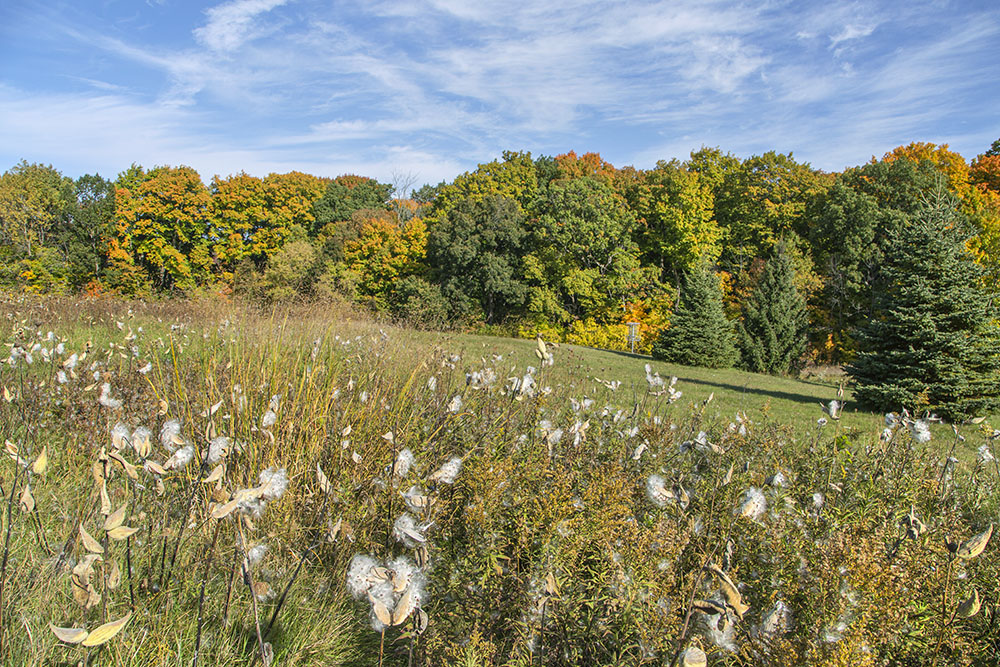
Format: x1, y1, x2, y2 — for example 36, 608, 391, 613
0, 296, 1000, 666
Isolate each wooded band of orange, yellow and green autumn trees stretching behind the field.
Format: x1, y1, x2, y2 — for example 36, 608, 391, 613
0, 140, 1000, 418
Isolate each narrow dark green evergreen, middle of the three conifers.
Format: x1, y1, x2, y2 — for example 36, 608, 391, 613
738, 248, 809, 374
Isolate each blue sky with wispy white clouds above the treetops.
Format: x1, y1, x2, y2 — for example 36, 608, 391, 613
0, 0, 1000, 185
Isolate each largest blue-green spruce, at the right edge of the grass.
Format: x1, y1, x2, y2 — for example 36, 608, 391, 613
848, 190, 1000, 419
